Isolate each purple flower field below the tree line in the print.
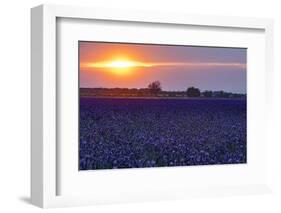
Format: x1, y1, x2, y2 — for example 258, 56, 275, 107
80, 98, 246, 170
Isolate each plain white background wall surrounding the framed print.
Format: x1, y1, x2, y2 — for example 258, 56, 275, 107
0, 0, 281, 213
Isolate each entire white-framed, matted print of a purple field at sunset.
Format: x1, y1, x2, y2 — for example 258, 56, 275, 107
31, 5, 273, 207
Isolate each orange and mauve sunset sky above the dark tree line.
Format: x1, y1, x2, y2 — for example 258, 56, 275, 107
79, 41, 247, 93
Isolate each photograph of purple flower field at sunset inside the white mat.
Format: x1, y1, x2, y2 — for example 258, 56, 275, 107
77, 41, 247, 171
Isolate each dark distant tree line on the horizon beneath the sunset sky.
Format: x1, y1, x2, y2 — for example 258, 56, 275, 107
80, 81, 246, 98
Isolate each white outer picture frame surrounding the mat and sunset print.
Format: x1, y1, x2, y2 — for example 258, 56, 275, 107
31, 5, 273, 208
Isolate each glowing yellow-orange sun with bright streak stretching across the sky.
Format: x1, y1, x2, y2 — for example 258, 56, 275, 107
80, 46, 246, 77
